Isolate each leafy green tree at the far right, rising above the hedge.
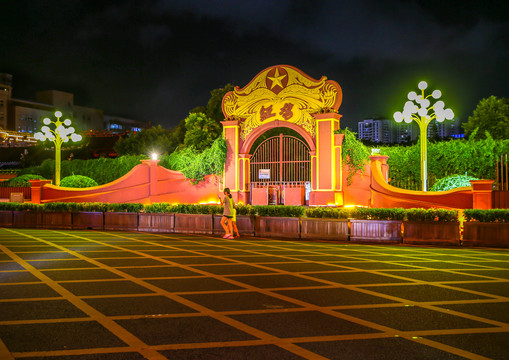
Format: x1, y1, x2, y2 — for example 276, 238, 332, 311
463, 96, 509, 139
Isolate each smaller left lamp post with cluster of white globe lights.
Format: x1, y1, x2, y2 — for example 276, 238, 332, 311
34, 111, 81, 186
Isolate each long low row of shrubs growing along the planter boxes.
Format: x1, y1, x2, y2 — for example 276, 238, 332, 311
0, 202, 509, 222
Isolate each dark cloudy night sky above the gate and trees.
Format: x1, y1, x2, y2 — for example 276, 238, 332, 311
0, 0, 509, 129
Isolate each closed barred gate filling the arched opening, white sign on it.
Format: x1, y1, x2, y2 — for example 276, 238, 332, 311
250, 134, 311, 205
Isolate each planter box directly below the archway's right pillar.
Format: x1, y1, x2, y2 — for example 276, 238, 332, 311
300, 219, 349, 241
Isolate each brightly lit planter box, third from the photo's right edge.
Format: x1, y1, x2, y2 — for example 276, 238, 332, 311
350, 220, 403, 243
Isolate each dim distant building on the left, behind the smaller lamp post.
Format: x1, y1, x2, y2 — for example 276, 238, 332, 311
0, 73, 150, 139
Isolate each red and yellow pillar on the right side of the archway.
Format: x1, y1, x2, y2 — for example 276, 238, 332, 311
309, 112, 343, 206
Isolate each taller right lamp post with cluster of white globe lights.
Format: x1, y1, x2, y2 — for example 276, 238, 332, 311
394, 81, 454, 191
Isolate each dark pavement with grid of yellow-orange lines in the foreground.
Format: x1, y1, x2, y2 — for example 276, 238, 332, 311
0, 229, 509, 360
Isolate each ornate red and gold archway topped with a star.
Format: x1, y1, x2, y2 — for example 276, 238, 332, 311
222, 65, 343, 205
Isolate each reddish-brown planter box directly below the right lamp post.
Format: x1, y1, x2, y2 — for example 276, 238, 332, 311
403, 221, 460, 246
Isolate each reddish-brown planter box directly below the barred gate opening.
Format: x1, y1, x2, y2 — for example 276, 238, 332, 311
255, 216, 300, 239
